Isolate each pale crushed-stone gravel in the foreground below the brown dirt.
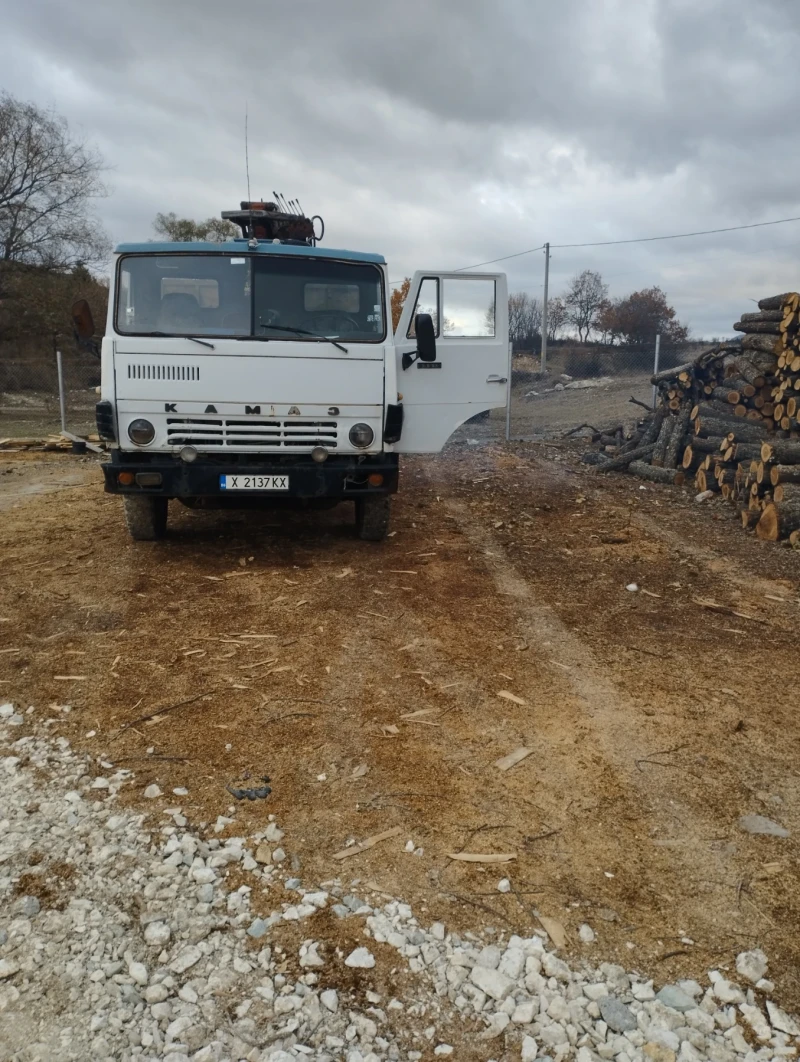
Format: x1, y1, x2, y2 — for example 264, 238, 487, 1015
0, 705, 800, 1062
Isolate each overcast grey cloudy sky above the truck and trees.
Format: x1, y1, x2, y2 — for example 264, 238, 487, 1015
0, 0, 800, 338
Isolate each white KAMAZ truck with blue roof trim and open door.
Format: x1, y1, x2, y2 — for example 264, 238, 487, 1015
73, 203, 508, 541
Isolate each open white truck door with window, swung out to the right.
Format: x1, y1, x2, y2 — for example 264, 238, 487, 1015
389, 272, 508, 453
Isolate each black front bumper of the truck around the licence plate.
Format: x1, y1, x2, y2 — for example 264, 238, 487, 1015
103, 450, 398, 500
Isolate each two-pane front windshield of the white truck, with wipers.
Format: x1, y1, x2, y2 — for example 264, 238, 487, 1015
116, 254, 386, 343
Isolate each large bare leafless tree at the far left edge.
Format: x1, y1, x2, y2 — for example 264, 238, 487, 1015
0, 92, 110, 270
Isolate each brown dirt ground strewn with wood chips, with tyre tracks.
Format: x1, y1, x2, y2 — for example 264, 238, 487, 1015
0, 446, 800, 1009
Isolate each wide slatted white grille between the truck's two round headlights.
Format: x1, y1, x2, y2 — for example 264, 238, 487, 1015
167, 416, 339, 450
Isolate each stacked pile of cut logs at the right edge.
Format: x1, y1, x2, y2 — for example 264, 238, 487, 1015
589, 292, 800, 548
